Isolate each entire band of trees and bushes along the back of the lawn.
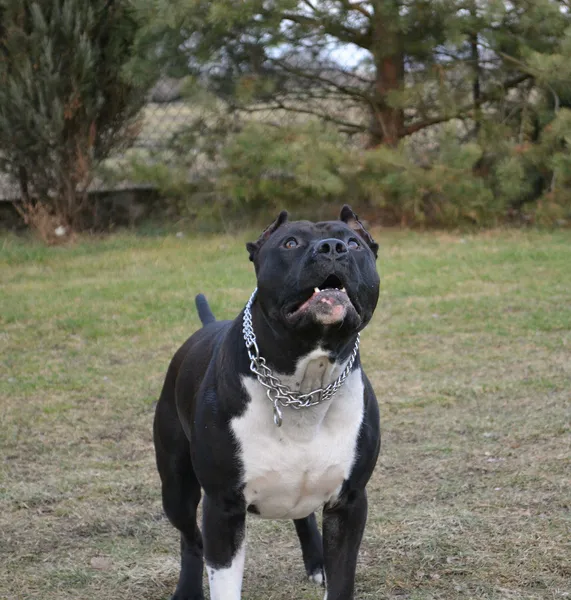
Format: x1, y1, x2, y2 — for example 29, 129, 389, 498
0, 0, 571, 228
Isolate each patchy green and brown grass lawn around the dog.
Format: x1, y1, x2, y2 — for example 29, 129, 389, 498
0, 231, 571, 600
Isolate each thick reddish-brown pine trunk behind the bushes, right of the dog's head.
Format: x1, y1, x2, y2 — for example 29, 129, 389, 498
369, 2, 404, 147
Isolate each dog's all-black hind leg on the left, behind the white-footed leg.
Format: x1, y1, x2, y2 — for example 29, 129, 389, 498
154, 385, 204, 600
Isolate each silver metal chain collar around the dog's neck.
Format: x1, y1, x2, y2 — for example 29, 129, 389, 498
242, 288, 360, 427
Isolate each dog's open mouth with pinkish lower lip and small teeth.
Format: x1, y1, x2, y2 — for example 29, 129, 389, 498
287, 275, 353, 325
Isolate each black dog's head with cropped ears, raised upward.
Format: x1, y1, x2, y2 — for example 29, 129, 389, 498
246, 205, 379, 334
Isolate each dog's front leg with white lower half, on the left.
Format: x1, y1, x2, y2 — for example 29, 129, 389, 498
202, 495, 246, 600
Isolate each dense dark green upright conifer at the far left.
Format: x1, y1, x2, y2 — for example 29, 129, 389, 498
0, 0, 144, 228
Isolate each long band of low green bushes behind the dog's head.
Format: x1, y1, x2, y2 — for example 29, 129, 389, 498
124, 99, 571, 227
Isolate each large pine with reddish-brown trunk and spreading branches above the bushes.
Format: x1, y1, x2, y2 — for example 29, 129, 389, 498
131, 0, 571, 146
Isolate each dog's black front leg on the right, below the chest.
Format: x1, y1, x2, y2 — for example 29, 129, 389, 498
323, 489, 367, 600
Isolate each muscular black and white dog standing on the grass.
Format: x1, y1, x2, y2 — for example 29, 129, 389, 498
154, 206, 380, 600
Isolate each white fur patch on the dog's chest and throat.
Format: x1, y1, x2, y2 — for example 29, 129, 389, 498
231, 350, 364, 519
